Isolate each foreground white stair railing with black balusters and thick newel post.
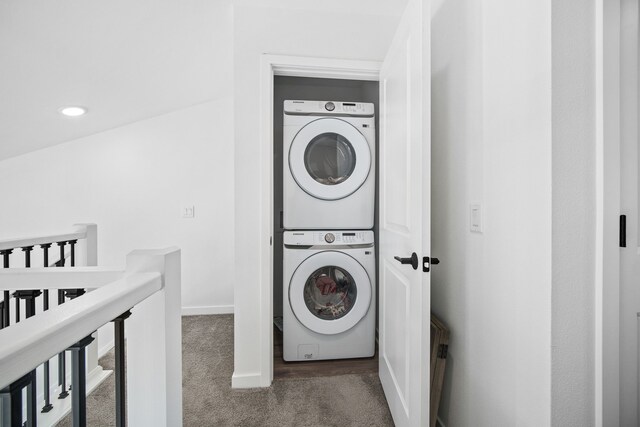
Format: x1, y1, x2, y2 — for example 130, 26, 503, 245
0, 242, 182, 427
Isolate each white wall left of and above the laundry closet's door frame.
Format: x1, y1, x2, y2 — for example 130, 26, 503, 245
233, 1, 398, 386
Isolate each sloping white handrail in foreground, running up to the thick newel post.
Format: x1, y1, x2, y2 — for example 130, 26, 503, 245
0, 273, 162, 388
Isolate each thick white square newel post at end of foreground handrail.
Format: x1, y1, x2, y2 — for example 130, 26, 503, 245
125, 248, 182, 427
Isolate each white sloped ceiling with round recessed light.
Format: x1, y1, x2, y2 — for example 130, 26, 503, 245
0, 0, 405, 160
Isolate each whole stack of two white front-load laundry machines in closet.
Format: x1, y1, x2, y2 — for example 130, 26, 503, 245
283, 101, 376, 361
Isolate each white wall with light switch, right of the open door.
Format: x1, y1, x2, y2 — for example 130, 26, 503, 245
432, 0, 552, 426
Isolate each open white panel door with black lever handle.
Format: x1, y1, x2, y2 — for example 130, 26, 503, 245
379, 0, 431, 427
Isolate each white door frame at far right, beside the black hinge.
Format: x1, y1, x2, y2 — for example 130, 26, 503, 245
594, 0, 620, 427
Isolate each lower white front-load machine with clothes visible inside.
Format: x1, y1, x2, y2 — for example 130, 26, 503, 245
282, 230, 376, 361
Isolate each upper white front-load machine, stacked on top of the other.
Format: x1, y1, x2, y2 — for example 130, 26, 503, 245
282, 101, 376, 230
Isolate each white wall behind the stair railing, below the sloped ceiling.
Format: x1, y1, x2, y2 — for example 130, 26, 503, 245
0, 98, 235, 314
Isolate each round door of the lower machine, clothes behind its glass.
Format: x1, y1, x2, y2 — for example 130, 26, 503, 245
289, 251, 372, 335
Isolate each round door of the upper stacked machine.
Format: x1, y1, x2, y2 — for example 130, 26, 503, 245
289, 118, 371, 200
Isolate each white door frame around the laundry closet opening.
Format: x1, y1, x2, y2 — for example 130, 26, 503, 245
259, 54, 382, 387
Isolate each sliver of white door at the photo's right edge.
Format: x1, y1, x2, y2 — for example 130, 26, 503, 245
619, 0, 640, 426
